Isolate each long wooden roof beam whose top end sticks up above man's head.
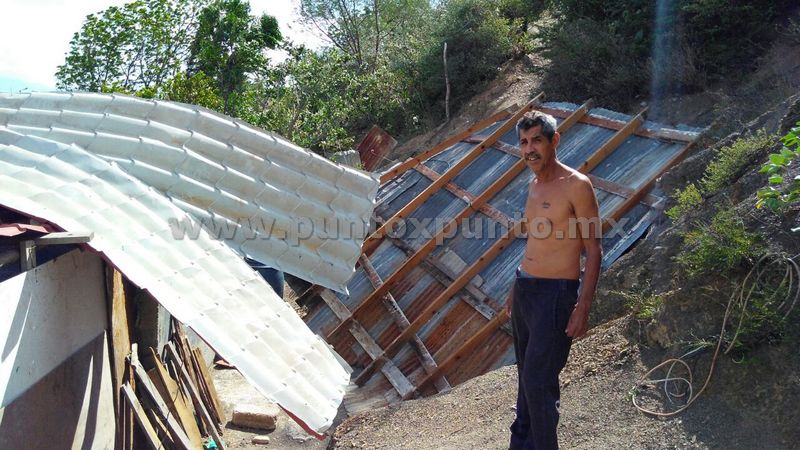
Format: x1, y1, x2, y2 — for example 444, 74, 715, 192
361, 94, 543, 255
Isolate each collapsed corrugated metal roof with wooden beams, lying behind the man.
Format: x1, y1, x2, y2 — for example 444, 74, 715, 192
305, 97, 700, 412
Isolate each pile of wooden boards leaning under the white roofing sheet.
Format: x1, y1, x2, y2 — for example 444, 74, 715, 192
119, 319, 226, 450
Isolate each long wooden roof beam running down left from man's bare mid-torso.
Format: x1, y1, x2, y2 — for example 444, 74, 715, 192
356, 222, 523, 384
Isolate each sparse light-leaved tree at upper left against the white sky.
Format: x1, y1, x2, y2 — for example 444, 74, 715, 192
56, 0, 205, 92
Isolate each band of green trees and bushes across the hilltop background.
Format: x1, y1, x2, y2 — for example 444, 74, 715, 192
56, 0, 788, 157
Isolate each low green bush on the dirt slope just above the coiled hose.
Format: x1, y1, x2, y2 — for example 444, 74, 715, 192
676, 207, 765, 278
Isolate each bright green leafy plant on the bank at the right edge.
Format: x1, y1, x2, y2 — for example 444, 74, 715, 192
756, 122, 800, 211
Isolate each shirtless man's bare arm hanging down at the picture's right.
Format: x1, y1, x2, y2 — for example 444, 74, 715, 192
566, 179, 603, 339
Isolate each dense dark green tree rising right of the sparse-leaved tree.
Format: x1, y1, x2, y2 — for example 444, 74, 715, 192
188, 0, 283, 114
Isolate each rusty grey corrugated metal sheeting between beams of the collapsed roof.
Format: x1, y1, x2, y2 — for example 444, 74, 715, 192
307, 103, 700, 411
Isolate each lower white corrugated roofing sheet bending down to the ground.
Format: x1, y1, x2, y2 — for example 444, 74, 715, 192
0, 126, 349, 431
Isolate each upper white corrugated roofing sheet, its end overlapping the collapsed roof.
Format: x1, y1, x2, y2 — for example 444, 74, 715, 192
0, 93, 379, 292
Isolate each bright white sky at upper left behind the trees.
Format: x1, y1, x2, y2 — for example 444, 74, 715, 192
0, 0, 321, 92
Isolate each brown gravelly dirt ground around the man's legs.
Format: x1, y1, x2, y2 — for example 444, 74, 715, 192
331, 318, 800, 450
